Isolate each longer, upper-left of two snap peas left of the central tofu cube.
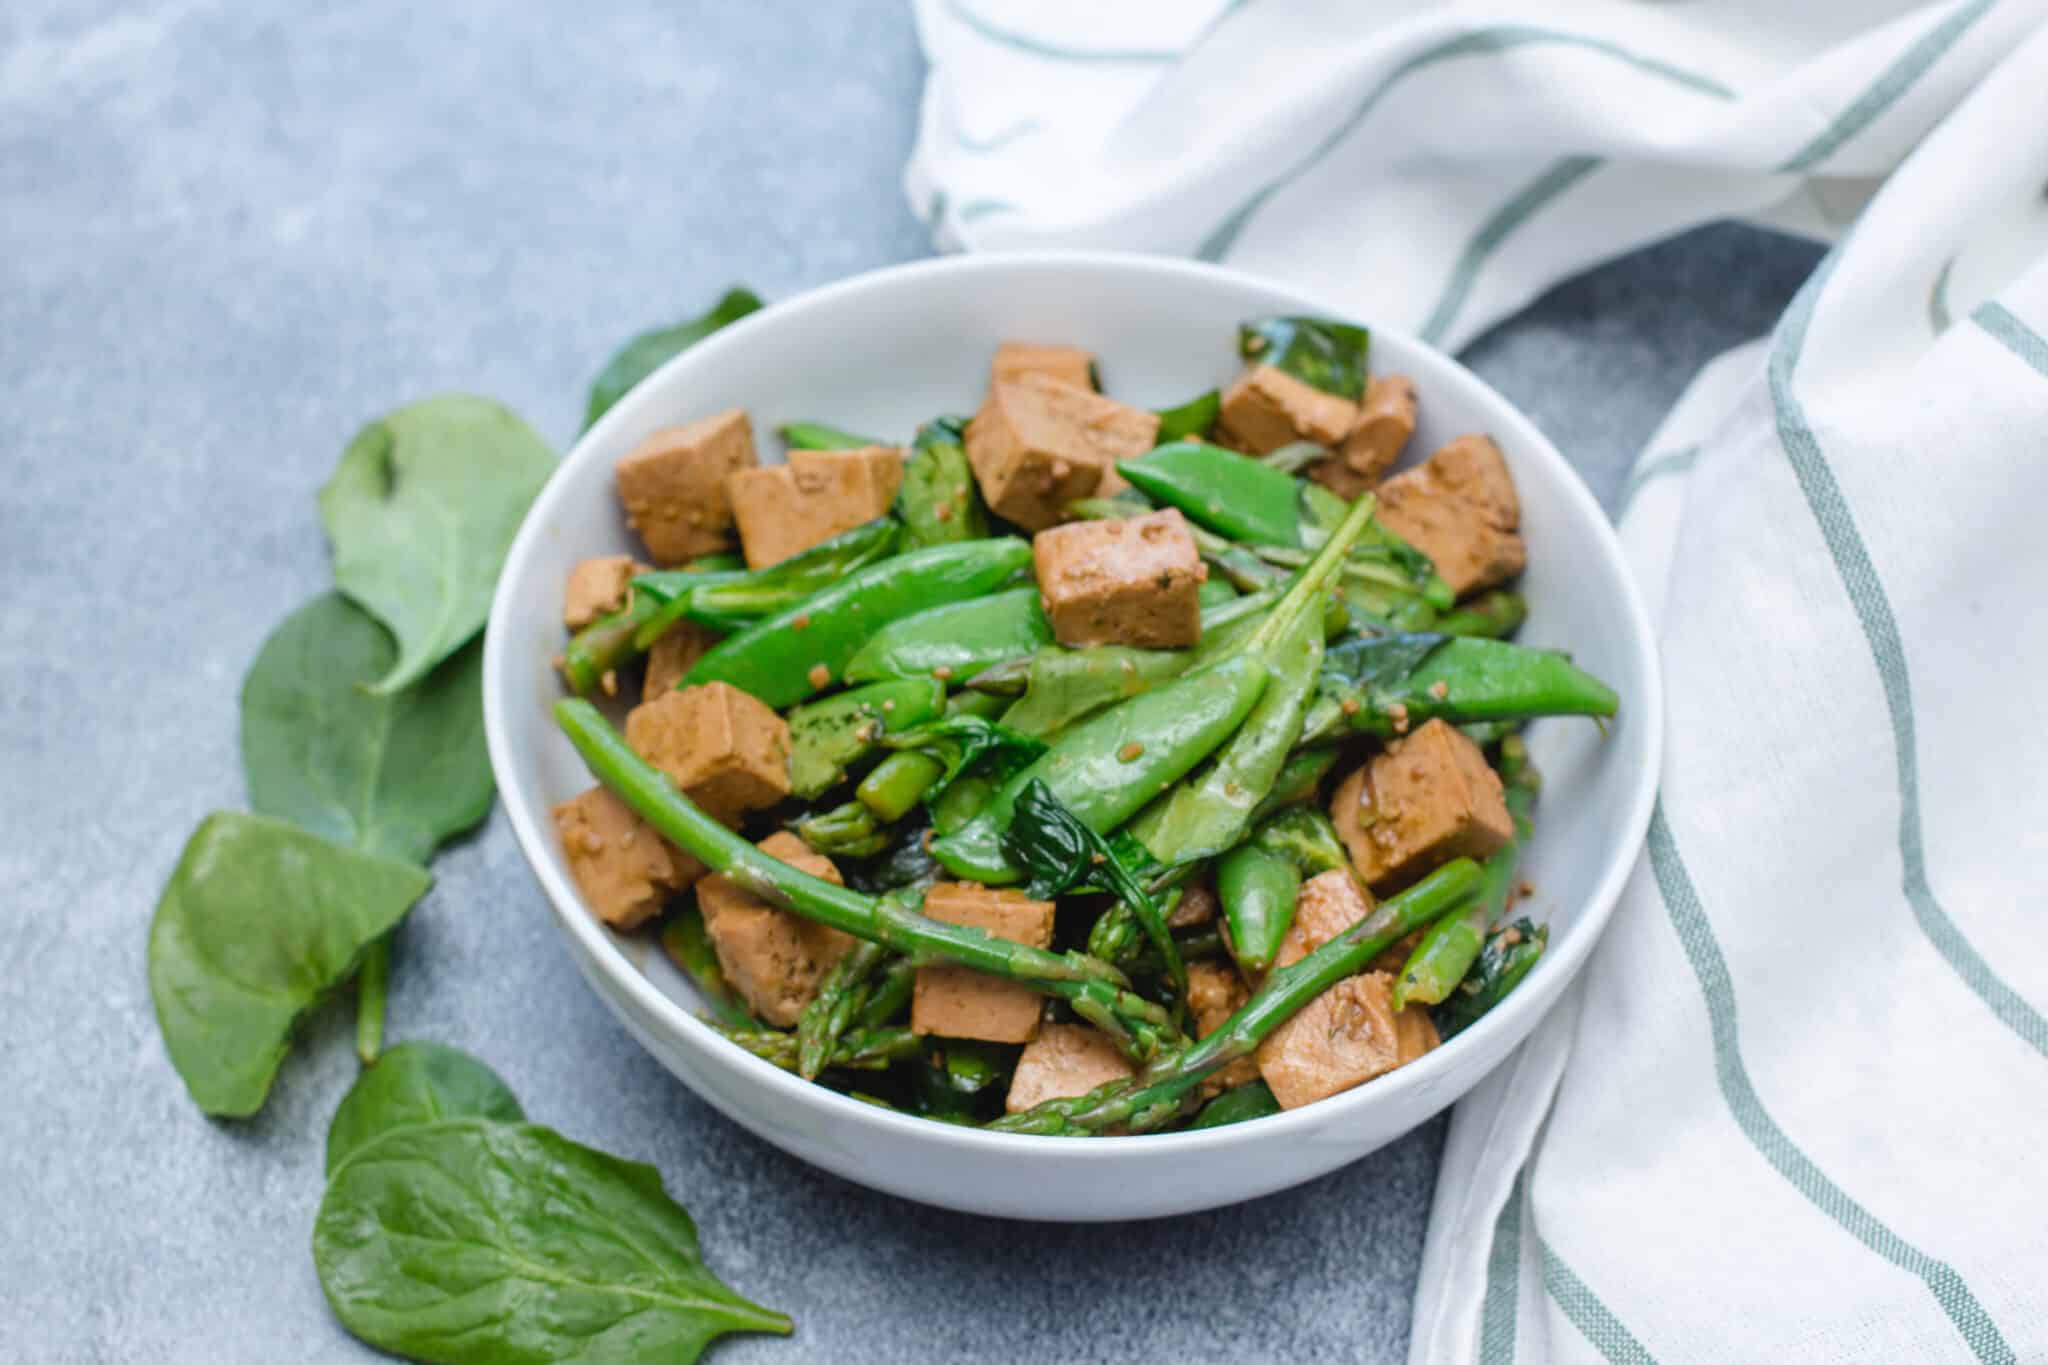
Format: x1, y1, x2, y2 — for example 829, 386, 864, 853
684, 536, 1030, 710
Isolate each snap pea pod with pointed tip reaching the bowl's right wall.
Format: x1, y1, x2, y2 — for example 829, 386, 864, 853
1303, 634, 1618, 743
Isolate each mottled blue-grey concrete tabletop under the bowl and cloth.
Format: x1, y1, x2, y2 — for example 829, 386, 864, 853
0, 0, 1815, 1365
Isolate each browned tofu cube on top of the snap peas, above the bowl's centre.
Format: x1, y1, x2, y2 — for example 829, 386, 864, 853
1030, 508, 1208, 649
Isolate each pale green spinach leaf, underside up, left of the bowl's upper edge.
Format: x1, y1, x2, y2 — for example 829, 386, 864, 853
319, 395, 555, 694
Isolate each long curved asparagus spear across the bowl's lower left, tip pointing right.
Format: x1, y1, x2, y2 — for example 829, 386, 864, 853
555, 698, 1180, 1060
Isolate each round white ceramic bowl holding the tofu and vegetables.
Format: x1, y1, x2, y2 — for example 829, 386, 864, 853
483, 254, 1663, 1222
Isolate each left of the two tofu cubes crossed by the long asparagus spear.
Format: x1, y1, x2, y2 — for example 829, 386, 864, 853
696, 831, 854, 1027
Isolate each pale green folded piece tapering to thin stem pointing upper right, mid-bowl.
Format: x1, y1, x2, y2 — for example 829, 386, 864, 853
1130, 480, 1374, 866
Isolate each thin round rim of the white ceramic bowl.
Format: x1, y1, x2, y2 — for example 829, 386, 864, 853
483, 250, 1665, 1158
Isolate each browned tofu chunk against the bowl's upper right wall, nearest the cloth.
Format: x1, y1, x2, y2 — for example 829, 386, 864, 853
1378, 436, 1528, 598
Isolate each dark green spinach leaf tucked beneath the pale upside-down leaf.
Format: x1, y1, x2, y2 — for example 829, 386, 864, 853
242, 593, 492, 864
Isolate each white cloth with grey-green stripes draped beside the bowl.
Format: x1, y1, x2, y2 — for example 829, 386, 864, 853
905, 0, 2048, 1365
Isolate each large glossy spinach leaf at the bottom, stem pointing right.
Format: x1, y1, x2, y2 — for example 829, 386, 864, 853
313, 1119, 791, 1365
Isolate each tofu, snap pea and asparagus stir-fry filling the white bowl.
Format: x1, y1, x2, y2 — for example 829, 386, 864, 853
555, 317, 1616, 1136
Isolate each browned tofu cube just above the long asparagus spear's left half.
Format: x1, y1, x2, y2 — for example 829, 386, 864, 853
627, 684, 788, 825
